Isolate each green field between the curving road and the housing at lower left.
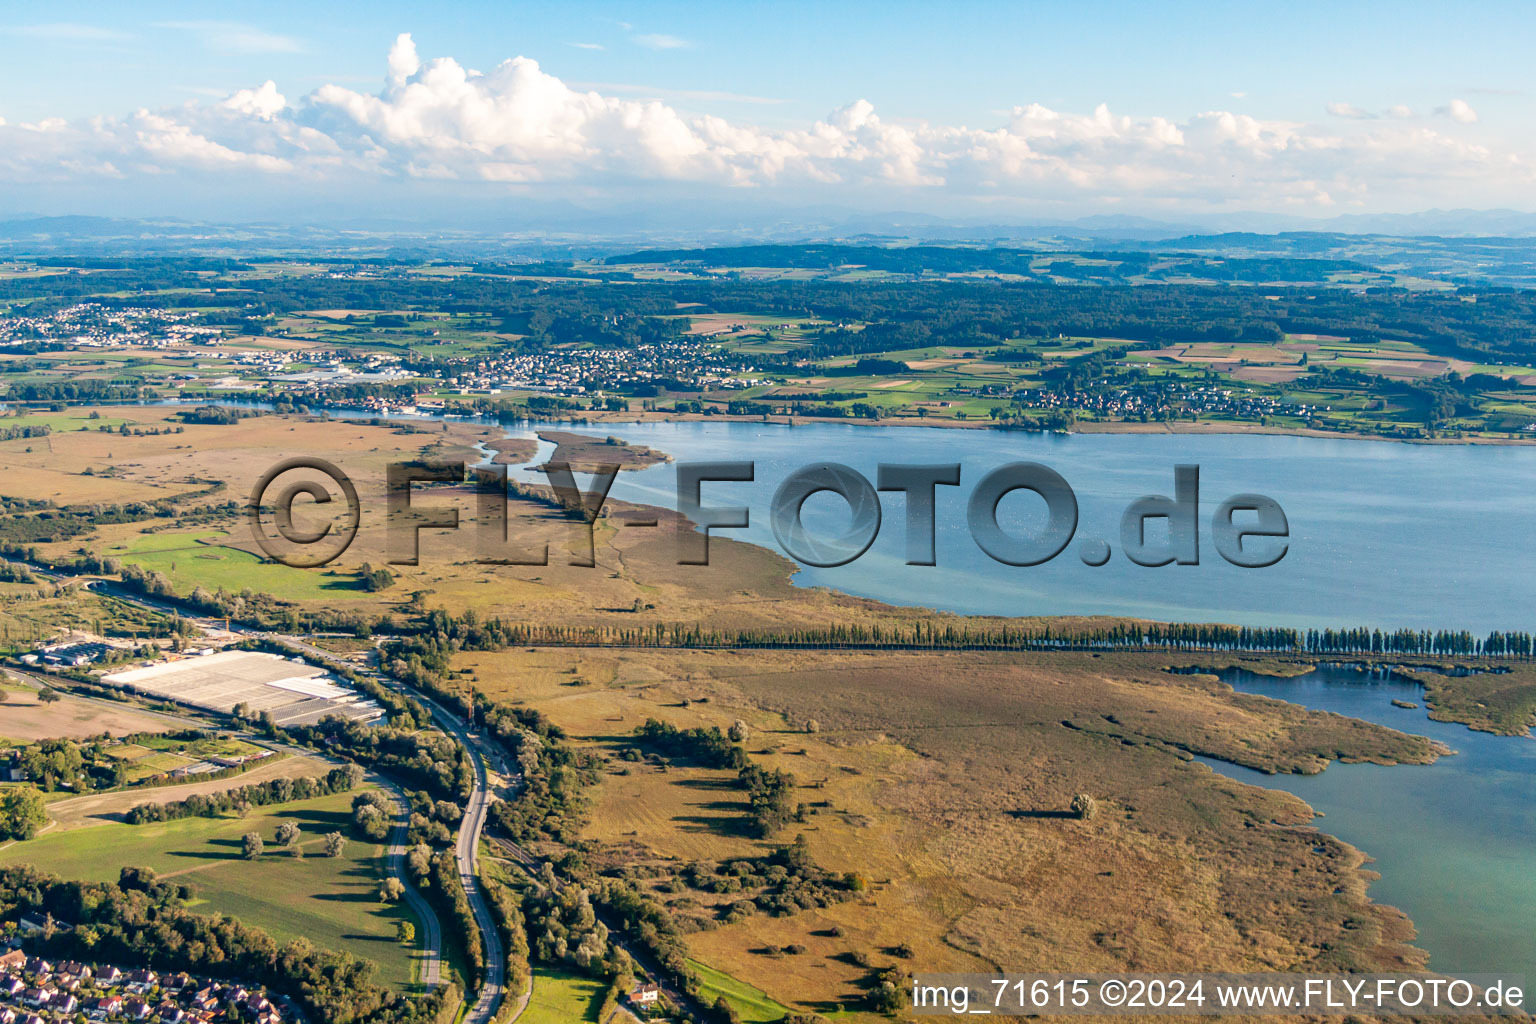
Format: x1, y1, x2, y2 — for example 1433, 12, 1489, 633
0, 794, 422, 989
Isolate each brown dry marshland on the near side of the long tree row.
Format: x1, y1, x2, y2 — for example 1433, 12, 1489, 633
456, 649, 1433, 1012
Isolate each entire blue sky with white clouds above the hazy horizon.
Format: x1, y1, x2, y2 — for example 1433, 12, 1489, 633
0, 0, 1536, 223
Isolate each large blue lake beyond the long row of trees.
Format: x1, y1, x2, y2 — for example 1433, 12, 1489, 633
511, 422, 1536, 634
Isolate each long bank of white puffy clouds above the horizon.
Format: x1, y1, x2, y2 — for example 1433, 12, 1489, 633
0, 35, 1536, 210
